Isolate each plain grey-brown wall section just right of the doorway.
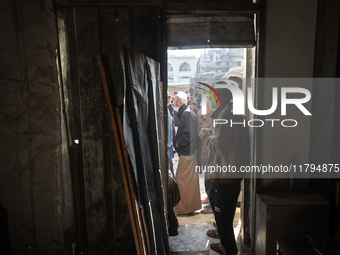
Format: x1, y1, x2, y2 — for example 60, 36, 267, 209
256, 0, 317, 190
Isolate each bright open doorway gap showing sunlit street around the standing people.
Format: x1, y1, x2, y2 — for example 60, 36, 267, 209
167, 47, 255, 254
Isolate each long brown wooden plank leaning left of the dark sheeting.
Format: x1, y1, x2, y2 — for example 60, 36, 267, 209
97, 55, 149, 255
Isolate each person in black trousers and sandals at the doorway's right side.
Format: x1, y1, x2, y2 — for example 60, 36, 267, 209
208, 80, 250, 255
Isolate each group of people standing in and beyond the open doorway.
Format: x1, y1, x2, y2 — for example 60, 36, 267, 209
167, 77, 250, 255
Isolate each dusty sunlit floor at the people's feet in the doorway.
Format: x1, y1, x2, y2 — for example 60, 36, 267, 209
169, 156, 254, 255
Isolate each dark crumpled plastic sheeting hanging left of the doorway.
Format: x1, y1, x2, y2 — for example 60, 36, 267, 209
122, 50, 168, 254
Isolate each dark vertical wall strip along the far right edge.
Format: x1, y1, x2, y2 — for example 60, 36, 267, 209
310, 0, 340, 237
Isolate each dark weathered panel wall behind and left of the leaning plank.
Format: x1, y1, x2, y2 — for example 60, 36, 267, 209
57, 5, 165, 254
